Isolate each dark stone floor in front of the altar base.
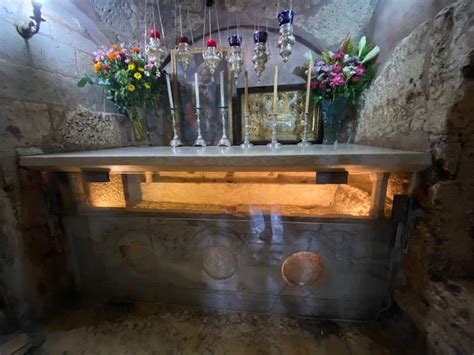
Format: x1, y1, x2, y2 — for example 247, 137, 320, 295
31, 304, 424, 355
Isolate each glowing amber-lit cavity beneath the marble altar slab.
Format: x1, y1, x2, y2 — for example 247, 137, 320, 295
78, 172, 373, 217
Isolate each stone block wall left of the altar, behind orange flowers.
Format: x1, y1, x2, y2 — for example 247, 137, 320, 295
0, 0, 131, 331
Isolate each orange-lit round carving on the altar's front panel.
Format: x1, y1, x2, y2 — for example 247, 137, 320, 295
281, 251, 324, 287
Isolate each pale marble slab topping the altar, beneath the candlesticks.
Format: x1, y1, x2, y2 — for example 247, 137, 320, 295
20, 144, 431, 172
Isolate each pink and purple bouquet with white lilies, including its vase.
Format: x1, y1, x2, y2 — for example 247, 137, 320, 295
305, 37, 380, 144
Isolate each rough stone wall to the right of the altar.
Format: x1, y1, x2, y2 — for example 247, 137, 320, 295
356, 1, 474, 354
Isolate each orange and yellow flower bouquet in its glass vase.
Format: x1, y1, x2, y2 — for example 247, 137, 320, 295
77, 45, 165, 144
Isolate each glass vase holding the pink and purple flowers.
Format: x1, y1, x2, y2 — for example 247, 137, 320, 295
320, 97, 349, 144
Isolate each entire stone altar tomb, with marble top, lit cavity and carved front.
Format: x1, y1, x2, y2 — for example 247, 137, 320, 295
20, 145, 429, 319
